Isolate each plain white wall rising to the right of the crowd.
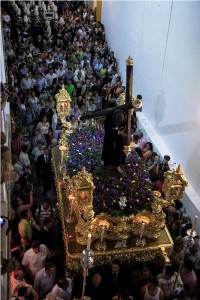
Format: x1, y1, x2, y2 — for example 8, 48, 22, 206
102, 1, 200, 232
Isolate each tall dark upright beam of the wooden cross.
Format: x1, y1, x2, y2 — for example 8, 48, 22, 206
125, 56, 133, 146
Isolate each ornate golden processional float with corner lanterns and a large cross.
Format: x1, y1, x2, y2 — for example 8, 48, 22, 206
52, 57, 188, 270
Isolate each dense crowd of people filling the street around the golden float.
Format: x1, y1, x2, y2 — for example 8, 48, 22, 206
1, 1, 200, 300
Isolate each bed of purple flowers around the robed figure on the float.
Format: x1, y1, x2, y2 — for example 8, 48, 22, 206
67, 128, 153, 216
